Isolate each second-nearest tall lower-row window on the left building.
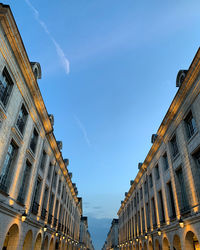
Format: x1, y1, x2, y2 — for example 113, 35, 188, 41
17, 161, 31, 204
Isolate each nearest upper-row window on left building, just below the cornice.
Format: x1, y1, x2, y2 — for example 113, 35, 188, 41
0, 68, 14, 106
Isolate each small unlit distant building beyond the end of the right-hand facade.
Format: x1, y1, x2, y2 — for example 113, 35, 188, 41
102, 219, 119, 250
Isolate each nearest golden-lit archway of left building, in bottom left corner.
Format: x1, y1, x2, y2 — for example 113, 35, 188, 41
2, 224, 19, 250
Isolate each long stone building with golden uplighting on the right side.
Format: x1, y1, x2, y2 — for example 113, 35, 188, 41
118, 49, 200, 250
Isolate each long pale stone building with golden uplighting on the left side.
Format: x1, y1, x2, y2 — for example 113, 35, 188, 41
0, 4, 93, 250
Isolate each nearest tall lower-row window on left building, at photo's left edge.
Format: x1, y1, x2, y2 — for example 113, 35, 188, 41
0, 141, 18, 192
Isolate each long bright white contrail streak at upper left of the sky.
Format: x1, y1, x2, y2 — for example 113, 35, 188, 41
25, 0, 70, 74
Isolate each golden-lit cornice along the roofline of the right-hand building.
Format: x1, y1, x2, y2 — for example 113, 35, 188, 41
117, 48, 200, 216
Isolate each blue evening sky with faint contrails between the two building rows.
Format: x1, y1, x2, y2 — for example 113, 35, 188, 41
3, 0, 200, 250
